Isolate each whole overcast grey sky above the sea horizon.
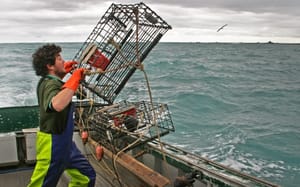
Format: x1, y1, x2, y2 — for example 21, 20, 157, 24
0, 0, 300, 43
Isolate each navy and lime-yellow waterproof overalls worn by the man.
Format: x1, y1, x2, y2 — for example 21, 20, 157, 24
28, 76, 96, 187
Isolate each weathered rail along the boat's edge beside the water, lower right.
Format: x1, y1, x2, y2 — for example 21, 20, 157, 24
147, 142, 279, 187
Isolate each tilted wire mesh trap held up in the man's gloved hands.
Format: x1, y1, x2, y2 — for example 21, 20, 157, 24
74, 3, 171, 104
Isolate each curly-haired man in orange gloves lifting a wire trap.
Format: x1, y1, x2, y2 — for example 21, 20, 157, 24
28, 44, 96, 187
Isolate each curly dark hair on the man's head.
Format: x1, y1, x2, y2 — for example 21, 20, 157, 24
32, 44, 62, 77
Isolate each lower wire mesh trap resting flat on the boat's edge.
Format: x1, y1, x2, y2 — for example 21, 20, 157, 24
85, 101, 175, 150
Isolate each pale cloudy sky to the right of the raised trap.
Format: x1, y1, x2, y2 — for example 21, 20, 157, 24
151, 0, 300, 42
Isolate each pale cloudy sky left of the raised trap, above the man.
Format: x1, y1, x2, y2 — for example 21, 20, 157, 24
0, 0, 108, 42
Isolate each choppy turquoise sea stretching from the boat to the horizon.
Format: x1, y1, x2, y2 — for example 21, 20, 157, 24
0, 42, 300, 187
